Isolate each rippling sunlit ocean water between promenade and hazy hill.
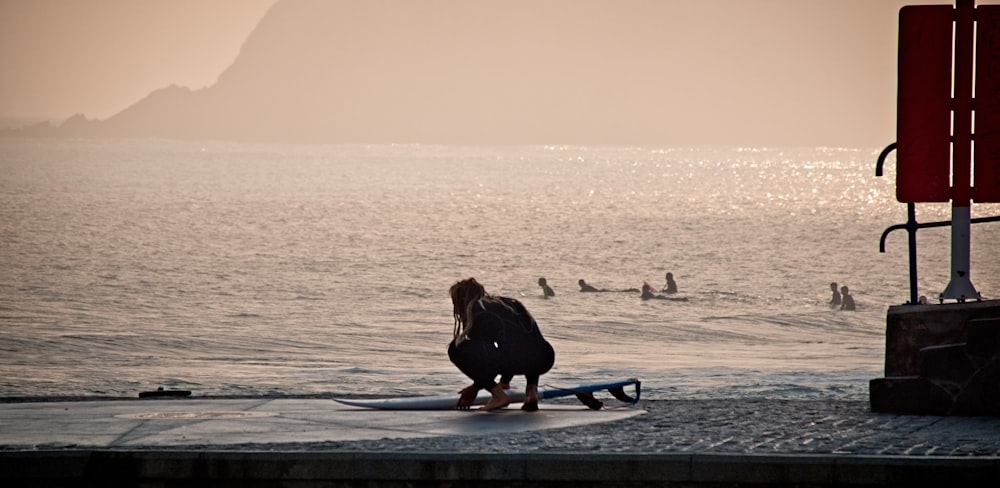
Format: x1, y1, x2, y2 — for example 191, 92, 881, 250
0, 140, 1000, 399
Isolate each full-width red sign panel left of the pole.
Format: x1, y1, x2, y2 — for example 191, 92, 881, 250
896, 5, 954, 202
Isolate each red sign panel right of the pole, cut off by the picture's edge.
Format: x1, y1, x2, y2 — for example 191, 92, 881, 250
972, 5, 1000, 202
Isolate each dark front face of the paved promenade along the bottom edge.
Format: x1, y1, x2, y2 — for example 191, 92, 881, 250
0, 450, 1000, 488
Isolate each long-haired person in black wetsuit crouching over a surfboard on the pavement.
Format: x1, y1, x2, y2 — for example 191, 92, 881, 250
448, 278, 556, 412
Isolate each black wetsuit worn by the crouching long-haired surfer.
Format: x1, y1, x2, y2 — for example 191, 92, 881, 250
448, 297, 556, 390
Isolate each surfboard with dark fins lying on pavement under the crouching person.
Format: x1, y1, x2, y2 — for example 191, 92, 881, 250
333, 378, 642, 410
